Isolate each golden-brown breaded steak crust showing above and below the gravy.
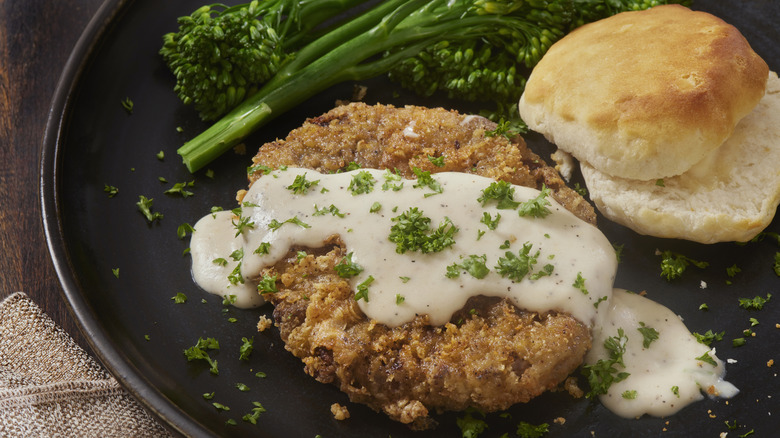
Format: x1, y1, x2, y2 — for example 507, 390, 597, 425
250, 103, 595, 429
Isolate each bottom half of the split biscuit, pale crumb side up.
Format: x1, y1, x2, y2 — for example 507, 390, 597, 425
580, 72, 780, 243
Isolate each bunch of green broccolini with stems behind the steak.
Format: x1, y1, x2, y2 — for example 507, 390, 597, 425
160, 0, 688, 172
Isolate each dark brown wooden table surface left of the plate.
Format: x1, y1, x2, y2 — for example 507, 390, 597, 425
0, 0, 102, 351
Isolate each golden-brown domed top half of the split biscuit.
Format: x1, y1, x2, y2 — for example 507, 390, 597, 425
519, 5, 769, 180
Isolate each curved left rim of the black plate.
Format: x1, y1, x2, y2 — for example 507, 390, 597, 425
40, 0, 777, 436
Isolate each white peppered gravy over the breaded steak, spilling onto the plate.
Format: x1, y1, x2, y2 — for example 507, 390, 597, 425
186, 168, 733, 416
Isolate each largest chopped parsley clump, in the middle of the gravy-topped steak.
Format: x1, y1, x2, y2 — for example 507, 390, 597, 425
387, 207, 458, 254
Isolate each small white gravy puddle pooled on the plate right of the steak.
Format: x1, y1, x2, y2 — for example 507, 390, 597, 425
585, 289, 739, 418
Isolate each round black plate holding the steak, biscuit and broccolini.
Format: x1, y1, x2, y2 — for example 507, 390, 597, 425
41, 0, 780, 438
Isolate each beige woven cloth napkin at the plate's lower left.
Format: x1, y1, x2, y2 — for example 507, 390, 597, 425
0, 292, 171, 438
